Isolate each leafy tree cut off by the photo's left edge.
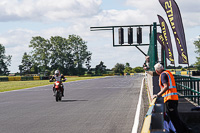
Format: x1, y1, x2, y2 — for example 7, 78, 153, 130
0, 44, 12, 75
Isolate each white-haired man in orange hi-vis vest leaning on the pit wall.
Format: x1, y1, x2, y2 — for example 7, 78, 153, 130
153, 63, 191, 133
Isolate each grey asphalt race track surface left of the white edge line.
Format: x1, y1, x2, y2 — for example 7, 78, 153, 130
0, 76, 143, 133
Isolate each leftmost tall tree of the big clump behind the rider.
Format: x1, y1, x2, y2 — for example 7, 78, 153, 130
29, 36, 51, 72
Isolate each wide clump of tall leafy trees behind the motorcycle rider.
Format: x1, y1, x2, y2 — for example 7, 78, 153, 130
29, 35, 92, 75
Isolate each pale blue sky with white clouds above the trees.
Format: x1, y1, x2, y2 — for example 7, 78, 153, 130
0, 0, 200, 73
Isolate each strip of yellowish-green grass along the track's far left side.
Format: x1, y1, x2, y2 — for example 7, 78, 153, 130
0, 76, 104, 92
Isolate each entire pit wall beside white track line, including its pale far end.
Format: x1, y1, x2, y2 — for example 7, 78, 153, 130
142, 71, 166, 133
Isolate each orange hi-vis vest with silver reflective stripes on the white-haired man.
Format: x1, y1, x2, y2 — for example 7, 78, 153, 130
159, 70, 178, 103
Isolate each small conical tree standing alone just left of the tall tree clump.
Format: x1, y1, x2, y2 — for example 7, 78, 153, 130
19, 52, 33, 74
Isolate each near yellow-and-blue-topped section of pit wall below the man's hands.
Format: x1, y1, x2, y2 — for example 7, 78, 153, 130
141, 97, 166, 133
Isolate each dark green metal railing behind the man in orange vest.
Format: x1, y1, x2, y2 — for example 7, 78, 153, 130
174, 75, 200, 105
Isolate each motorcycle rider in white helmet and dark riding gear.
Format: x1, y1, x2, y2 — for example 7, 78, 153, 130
50, 70, 67, 97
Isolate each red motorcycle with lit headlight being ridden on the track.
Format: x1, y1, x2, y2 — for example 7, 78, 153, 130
49, 80, 65, 102
